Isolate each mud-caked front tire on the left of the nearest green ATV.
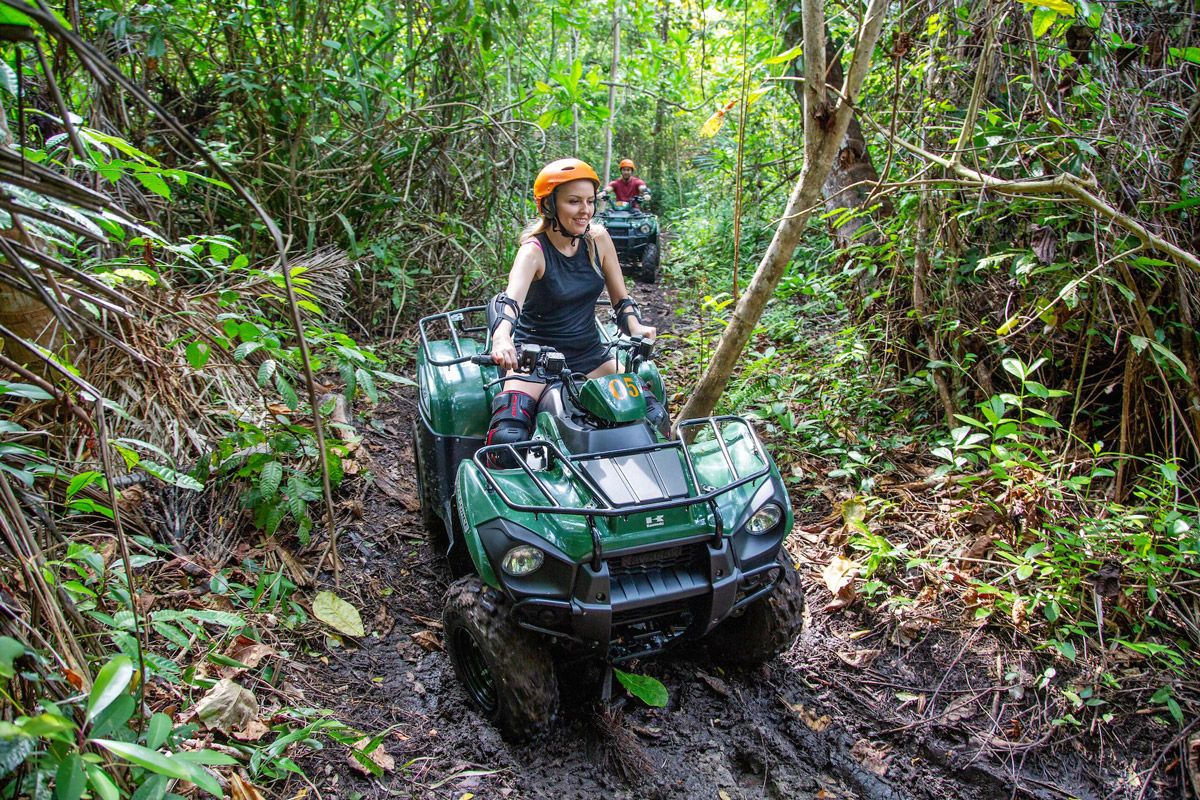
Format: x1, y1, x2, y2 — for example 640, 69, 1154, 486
442, 576, 558, 741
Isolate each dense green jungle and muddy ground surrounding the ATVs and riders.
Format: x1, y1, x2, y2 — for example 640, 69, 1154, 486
0, 0, 1200, 800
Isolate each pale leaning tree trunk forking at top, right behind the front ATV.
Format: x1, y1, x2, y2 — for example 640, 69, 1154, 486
679, 0, 887, 420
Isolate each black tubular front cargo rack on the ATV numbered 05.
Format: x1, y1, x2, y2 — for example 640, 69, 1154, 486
472, 415, 770, 569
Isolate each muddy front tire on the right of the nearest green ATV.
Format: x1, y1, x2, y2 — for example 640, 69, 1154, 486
708, 548, 804, 666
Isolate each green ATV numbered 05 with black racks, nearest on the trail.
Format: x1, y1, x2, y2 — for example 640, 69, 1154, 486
413, 306, 804, 740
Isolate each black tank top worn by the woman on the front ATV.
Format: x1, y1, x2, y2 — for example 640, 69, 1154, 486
512, 227, 605, 371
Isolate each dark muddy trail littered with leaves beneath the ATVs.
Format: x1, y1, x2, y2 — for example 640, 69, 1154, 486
289, 278, 1176, 800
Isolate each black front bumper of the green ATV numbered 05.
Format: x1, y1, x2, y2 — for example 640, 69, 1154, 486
514, 539, 784, 662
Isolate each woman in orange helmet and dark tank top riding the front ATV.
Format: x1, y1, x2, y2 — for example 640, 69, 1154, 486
487, 158, 668, 455
